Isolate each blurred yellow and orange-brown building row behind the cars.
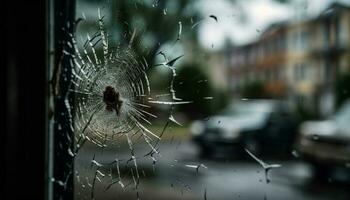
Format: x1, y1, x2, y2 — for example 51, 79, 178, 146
229, 4, 350, 116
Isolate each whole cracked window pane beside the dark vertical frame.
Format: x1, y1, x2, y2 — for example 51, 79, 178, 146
52, 0, 350, 200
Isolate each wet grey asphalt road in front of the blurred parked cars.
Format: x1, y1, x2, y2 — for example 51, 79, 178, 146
76, 141, 350, 200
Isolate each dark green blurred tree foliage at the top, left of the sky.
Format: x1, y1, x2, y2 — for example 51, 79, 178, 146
111, 0, 199, 63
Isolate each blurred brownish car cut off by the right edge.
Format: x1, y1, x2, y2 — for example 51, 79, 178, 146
296, 100, 350, 178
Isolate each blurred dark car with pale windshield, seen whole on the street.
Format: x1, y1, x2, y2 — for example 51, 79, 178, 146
191, 100, 297, 155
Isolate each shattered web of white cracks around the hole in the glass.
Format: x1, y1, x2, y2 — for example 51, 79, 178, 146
66, 6, 201, 199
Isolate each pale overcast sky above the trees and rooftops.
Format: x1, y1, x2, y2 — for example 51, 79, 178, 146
195, 0, 350, 49
